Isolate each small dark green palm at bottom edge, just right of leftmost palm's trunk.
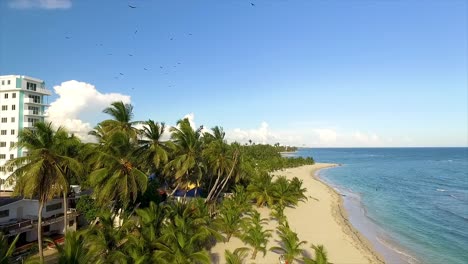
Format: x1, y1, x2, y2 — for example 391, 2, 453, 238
46, 231, 91, 264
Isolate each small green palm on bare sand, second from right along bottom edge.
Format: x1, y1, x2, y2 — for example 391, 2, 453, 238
270, 222, 307, 263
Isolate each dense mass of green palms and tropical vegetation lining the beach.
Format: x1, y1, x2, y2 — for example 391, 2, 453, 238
2, 102, 322, 264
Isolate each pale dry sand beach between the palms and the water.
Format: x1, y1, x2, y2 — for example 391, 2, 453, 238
211, 163, 384, 264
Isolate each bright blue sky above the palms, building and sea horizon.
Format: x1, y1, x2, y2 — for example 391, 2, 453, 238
0, 0, 468, 147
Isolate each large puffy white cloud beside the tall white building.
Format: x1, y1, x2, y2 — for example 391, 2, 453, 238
47, 80, 130, 141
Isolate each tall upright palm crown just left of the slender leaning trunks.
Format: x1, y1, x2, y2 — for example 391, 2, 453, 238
164, 118, 205, 192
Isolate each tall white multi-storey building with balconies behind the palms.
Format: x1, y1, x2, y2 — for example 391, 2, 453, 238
0, 75, 52, 191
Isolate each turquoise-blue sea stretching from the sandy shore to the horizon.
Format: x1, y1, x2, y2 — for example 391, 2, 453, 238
294, 148, 468, 264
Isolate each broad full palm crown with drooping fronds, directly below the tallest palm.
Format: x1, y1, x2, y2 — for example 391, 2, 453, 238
89, 131, 148, 209
